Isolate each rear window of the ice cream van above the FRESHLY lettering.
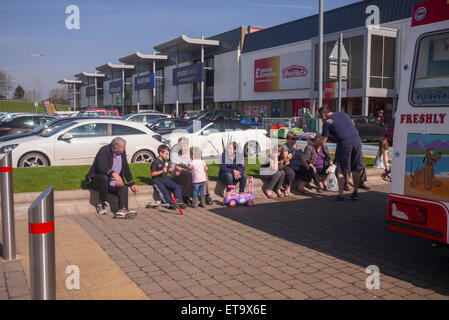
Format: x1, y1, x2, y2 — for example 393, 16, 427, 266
410, 30, 449, 106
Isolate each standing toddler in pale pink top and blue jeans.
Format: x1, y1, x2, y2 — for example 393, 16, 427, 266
189, 147, 207, 208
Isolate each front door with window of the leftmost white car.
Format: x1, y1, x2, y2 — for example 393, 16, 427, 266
55, 123, 112, 165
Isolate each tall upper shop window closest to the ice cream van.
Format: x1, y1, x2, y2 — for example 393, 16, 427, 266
370, 35, 396, 89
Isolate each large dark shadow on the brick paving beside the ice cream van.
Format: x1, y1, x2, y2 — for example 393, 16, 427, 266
210, 191, 449, 295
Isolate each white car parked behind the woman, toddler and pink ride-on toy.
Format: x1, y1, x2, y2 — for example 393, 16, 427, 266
163, 120, 272, 160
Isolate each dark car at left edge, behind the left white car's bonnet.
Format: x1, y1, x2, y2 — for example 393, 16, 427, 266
0, 114, 56, 137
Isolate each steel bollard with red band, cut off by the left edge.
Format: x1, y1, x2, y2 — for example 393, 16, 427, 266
0, 151, 16, 260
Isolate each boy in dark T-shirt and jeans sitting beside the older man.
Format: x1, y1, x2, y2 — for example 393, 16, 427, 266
151, 144, 186, 209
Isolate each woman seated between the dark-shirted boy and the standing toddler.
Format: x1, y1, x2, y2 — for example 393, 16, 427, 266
170, 137, 212, 205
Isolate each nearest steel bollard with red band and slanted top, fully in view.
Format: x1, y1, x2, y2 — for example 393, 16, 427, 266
28, 186, 56, 300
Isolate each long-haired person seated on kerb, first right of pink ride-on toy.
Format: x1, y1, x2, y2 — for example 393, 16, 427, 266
260, 144, 286, 199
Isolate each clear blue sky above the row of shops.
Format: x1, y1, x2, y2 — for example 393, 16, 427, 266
0, 0, 358, 98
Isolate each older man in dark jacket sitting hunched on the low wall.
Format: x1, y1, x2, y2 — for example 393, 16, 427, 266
86, 137, 139, 219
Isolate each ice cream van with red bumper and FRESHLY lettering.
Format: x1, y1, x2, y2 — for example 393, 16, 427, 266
387, 0, 449, 244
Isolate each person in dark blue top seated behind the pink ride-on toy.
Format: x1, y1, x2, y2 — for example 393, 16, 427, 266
218, 142, 248, 193
